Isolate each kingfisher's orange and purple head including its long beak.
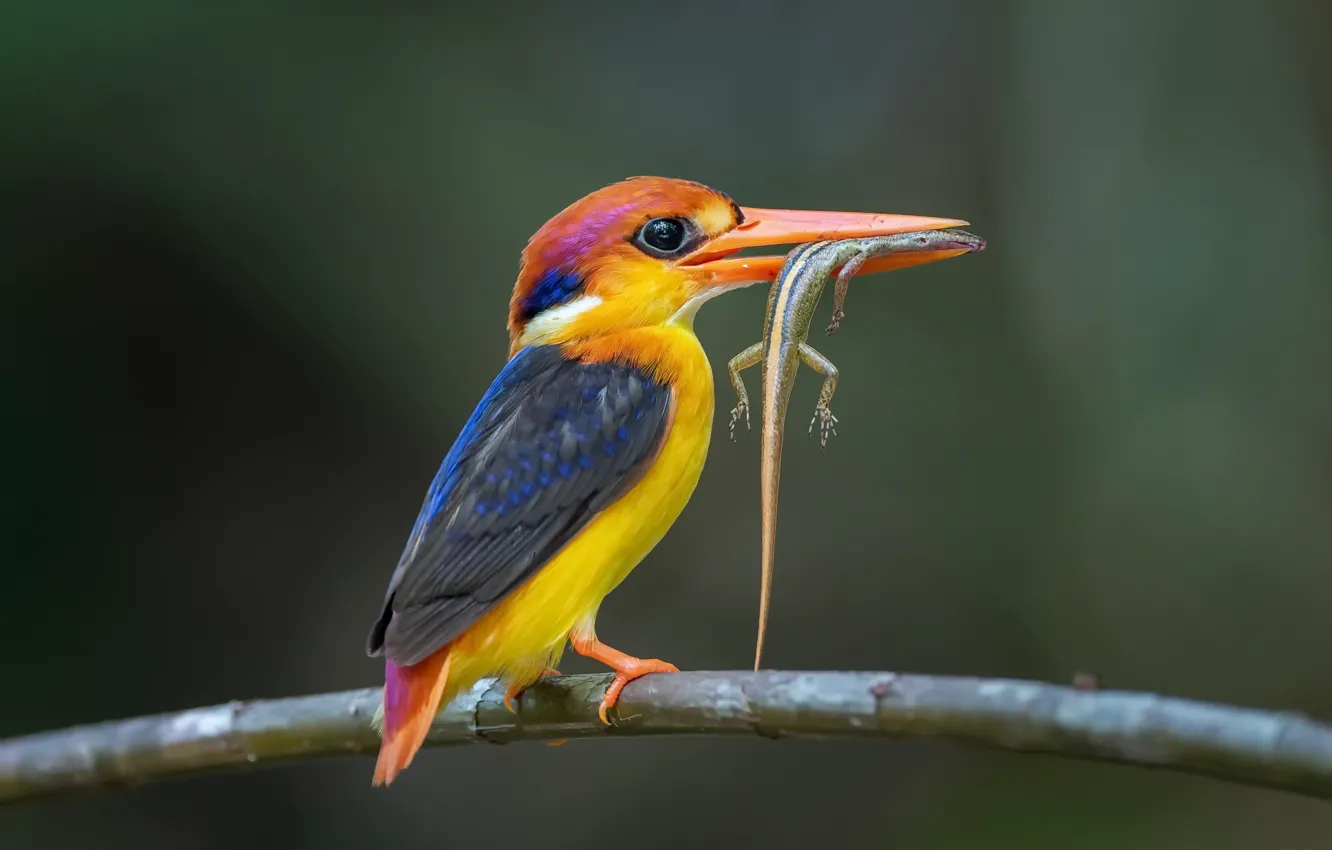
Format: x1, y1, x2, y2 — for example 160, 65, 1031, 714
509, 177, 967, 350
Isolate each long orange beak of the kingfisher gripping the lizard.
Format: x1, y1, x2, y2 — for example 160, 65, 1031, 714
683, 207, 968, 288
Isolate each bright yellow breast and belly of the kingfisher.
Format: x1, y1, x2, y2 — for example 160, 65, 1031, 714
445, 326, 713, 699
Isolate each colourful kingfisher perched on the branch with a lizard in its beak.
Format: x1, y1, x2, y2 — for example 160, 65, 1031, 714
366, 177, 967, 786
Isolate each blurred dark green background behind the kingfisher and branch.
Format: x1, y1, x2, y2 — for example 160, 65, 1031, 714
0, 0, 1332, 850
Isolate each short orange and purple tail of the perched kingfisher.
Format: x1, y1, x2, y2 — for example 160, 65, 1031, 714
373, 646, 452, 785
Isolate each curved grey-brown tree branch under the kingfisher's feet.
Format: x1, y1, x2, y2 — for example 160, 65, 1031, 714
0, 671, 1332, 803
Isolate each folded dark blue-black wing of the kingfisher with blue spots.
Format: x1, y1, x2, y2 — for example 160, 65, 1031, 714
366, 345, 670, 665
